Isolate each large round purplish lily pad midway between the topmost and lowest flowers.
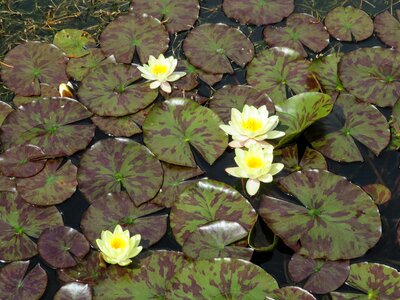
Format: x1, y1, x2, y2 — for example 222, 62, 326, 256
78, 138, 163, 205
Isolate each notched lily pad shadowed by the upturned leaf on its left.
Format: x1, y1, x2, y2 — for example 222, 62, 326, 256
306, 94, 390, 162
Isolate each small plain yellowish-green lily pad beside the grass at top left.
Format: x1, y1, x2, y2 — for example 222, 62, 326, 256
53, 29, 96, 57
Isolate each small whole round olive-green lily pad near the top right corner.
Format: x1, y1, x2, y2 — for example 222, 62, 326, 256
325, 6, 374, 42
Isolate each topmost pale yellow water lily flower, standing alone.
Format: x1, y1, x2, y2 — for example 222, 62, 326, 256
138, 54, 186, 93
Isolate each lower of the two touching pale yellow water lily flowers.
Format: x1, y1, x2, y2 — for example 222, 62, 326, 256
225, 144, 283, 196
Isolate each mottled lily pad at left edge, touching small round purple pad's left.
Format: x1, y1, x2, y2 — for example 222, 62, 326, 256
0, 193, 63, 261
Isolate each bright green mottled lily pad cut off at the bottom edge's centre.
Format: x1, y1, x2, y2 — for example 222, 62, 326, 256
167, 258, 278, 300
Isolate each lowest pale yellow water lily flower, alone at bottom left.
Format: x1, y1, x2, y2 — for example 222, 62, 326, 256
96, 225, 143, 266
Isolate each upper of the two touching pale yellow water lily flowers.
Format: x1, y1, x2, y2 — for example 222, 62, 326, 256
220, 104, 285, 148
